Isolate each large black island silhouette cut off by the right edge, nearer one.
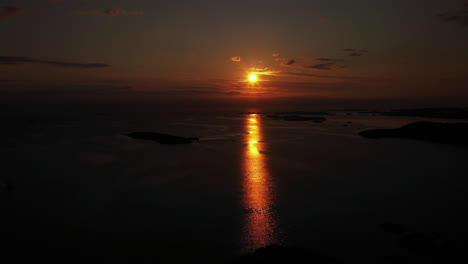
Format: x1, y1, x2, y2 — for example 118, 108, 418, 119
359, 122, 468, 146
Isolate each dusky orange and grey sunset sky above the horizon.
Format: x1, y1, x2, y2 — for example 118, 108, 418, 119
0, 0, 468, 101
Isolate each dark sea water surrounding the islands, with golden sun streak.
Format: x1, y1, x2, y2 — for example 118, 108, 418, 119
0, 105, 468, 263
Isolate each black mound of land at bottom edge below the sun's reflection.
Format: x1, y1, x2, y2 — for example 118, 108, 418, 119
234, 245, 342, 264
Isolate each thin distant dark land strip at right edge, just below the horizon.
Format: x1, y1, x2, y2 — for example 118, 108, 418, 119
360, 108, 468, 119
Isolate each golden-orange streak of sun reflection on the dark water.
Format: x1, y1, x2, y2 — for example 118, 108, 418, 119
243, 114, 277, 251
